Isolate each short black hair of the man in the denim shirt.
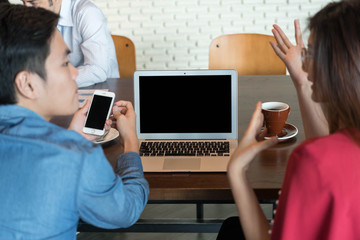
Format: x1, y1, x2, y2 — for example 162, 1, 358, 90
0, 4, 59, 104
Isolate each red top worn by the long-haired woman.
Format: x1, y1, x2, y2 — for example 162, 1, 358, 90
272, 129, 360, 240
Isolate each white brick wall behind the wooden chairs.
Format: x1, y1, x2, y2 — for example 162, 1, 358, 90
10, 0, 331, 69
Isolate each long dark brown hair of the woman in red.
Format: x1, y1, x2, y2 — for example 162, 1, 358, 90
309, 1, 360, 133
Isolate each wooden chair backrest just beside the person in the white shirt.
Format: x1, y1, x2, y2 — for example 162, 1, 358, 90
111, 35, 136, 78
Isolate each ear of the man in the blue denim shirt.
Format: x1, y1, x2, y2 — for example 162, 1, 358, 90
15, 71, 37, 99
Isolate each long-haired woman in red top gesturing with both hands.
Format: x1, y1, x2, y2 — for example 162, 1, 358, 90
219, 1, 360, 240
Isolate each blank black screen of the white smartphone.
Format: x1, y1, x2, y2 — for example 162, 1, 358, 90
85, 95, 112, 130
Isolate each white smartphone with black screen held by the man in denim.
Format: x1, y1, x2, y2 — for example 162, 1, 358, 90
83, 90, 115, 136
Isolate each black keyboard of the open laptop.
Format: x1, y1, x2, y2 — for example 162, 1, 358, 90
140, 141, 230, 157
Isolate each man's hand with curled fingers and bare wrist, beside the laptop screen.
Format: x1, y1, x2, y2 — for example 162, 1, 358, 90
112, 101, 139, 153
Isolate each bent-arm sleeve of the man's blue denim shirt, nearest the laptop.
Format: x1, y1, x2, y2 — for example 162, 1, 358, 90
77, 148, 149, 228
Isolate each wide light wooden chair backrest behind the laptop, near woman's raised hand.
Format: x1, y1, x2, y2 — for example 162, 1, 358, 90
209, 33, 286, 75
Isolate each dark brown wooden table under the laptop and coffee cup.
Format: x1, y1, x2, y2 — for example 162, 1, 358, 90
53, 75, 305, 232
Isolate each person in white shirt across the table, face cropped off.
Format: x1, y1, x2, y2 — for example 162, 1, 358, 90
23, 0, 120, 87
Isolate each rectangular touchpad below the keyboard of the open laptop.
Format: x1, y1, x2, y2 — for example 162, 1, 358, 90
163, 158, 201, 171
